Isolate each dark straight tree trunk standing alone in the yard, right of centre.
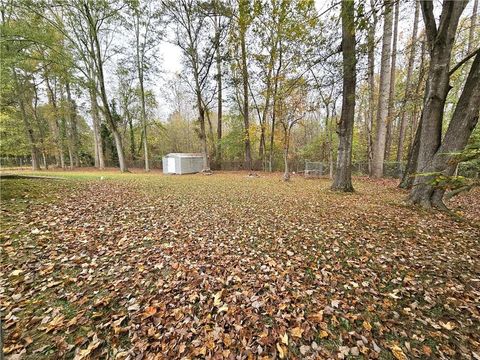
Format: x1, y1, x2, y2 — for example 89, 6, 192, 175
332, 1, 356, 192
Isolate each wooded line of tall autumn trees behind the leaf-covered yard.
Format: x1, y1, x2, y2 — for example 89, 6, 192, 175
0, 0, 480, 207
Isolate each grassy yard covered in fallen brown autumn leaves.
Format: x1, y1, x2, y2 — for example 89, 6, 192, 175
0, 171, 480, 359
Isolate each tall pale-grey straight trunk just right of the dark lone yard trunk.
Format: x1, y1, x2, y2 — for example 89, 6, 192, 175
371, 0, 392, 178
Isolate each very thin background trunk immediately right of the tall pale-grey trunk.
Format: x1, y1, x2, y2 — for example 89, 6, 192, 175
385, 1, 400, 161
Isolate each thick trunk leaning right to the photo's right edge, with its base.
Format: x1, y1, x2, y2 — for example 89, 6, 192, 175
409, 55, 480, 209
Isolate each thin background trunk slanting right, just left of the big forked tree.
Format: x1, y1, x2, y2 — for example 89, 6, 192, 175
397, 1, 420, 165
